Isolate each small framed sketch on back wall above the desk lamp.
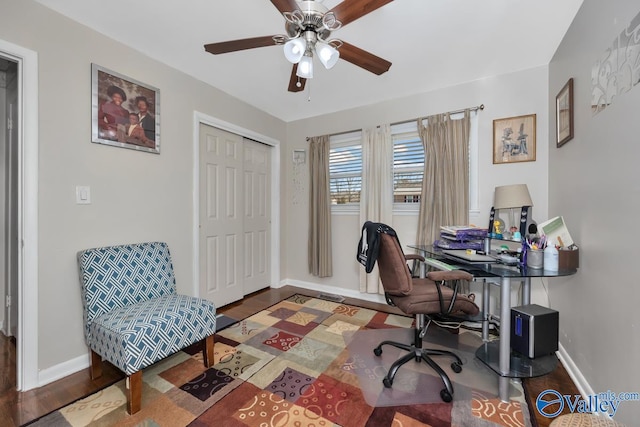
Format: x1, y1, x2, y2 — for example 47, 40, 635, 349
493, 114, 536, 164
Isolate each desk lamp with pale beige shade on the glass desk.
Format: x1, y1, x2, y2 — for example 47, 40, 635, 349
490, 184, 533, 241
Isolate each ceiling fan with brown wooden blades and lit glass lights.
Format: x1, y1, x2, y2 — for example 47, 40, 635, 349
204, 0, 393, 92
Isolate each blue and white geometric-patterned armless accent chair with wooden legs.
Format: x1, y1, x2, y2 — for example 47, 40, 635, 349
78, 242, 216, 414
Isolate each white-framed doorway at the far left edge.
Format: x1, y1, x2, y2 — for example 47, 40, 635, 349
0, 40, 39, 391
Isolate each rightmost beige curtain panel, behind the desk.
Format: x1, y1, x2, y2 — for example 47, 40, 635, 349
416, 109, 471, 245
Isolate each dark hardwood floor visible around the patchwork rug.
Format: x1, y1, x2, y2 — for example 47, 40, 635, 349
0, 286, 578, 427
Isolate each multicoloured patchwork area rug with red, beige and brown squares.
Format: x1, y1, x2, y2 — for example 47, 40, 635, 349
26, 295, 531, 427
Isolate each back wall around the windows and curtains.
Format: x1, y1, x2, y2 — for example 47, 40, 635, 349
281, 66, 549, 304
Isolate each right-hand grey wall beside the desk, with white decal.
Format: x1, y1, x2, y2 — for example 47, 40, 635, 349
548, 0, 640, 426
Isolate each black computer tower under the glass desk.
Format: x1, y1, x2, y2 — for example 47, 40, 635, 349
511, 304, 559, 359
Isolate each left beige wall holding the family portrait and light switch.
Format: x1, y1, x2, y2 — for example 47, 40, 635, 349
0, 0, 285, 378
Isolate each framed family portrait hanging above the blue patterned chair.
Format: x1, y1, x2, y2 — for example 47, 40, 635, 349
91, 64, 160, 154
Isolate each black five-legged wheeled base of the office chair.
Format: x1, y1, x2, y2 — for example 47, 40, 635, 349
373, 329, 462, 403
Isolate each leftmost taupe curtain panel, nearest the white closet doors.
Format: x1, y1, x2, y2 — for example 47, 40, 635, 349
308, 135, 333, 277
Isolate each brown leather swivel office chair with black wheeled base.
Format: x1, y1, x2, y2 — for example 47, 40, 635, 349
370, 223, 479, 402
